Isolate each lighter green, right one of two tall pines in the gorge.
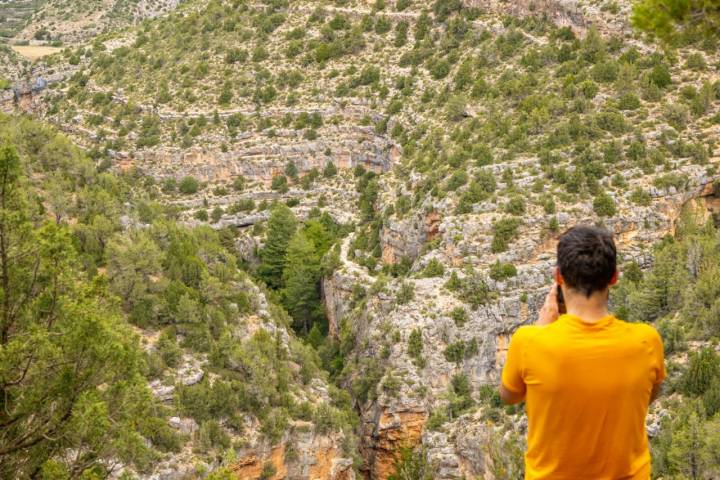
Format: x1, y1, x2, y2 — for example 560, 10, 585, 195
282, 231, 320, 335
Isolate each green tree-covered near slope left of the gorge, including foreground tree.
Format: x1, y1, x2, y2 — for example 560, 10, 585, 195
0, 116, 355, 478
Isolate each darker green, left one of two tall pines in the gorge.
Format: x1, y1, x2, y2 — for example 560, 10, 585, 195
257, 204, 297, 288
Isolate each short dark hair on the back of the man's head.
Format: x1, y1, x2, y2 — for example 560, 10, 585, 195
557, 225, 617, 297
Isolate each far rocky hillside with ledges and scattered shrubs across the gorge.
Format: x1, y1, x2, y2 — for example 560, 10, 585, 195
12, 0, 720, 479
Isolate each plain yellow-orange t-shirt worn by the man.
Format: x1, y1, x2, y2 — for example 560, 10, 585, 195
502, 315, 666, 480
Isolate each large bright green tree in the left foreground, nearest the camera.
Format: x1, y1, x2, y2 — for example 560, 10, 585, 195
0, 145, 163, 478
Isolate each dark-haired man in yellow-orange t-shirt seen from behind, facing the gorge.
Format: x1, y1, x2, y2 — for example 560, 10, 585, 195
500, 226, 665, 480
